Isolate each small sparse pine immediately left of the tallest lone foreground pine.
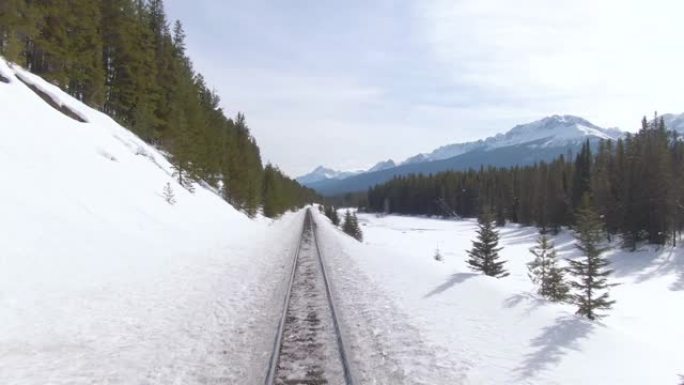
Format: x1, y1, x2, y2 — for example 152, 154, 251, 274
527, 234, 569, 302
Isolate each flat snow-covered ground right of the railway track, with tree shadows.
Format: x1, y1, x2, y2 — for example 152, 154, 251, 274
317, 214, 684, 384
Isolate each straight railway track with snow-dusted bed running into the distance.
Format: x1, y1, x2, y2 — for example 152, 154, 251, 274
265, 210, 354, 385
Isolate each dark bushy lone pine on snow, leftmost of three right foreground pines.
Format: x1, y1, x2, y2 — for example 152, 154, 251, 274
466, 211, 508, 278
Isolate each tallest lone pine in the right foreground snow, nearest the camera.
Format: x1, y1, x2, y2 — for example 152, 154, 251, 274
568, 195, 615, 320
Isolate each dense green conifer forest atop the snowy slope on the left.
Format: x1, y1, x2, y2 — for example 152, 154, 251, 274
0, 0, 316, 216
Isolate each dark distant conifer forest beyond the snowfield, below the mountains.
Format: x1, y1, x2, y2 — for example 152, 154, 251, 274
367, 117, 684, 249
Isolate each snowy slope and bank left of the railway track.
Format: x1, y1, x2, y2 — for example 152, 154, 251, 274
0, 58, 302, 385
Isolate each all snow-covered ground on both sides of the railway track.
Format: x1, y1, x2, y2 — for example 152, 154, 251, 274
0, 54, 684, 385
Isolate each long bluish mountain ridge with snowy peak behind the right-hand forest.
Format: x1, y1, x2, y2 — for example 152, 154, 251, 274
299, 115, 623, 195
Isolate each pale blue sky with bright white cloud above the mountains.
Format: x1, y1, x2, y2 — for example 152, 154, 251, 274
166, 0, 684, 176
